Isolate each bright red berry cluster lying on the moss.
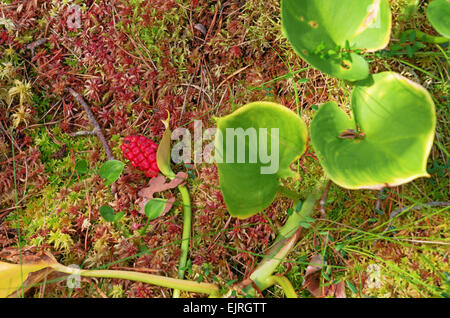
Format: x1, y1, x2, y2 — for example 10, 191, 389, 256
120, 136, 159, 178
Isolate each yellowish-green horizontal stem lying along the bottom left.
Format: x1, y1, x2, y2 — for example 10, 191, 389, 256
52, 264, 220, 296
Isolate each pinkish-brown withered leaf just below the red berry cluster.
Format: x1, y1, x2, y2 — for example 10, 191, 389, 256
138, 172, 188, 215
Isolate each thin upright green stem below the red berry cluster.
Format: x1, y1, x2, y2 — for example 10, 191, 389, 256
173, 185, 192, 298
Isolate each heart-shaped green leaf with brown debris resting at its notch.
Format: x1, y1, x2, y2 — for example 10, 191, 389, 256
311, 72, 435, 189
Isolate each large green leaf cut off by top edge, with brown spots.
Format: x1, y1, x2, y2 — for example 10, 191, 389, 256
281, 0, 391, 81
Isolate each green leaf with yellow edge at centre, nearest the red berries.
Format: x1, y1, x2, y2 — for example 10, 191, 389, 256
215, 102, 308, 218
